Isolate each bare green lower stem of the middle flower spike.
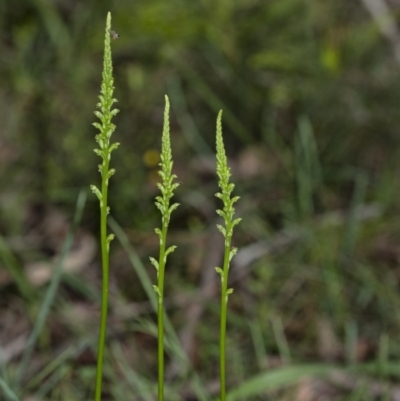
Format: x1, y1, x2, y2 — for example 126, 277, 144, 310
157, 224, 167, 401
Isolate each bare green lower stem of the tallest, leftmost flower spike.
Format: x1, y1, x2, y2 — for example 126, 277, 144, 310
95, 157, 109, 401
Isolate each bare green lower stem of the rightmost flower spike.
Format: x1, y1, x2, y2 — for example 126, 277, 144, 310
219, 237, 231, 401
